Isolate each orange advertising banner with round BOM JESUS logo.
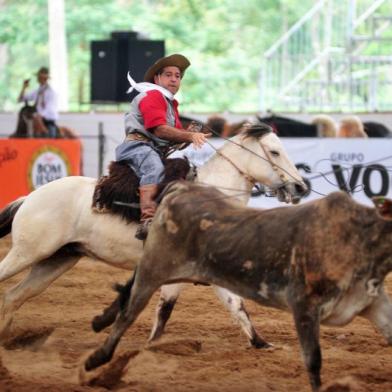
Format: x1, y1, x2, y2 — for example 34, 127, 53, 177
0, 139, 81, 208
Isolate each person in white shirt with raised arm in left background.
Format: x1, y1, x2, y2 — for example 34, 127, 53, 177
18, 67, 58, 138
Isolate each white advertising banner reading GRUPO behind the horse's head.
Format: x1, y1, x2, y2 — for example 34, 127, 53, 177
176, 138, 392, 208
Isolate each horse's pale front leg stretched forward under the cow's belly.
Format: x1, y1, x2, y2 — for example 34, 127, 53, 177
213, 286, 271, 348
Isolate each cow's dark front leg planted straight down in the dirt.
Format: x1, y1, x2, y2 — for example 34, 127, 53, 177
292, 301, 321, 391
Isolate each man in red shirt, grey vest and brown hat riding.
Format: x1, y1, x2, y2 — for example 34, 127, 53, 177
116, 54, 210, 240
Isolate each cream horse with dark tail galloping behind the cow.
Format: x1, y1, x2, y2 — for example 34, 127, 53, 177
0, 127, 306, 344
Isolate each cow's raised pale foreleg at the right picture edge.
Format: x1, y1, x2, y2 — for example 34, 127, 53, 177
361, 289, 392, 345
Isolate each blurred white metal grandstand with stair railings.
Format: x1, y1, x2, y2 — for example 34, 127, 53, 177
260, 0, 392, 113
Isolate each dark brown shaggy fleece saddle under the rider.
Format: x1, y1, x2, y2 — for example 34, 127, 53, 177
91, 158, 192, 223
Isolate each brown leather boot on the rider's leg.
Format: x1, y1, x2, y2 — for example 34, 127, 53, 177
135, 184, 158, 240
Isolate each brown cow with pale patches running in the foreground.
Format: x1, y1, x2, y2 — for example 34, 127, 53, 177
85, 183, 392, 390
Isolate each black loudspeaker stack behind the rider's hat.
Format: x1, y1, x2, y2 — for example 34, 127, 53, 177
91, 32, 165, 102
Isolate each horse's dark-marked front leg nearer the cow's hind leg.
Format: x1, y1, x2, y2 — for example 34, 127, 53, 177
148, 284, 183, 342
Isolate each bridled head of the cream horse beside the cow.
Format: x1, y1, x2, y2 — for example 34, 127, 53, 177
232, 123, 308, 204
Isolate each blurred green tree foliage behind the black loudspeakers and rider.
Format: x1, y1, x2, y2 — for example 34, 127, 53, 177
0, 0, 313, 112
